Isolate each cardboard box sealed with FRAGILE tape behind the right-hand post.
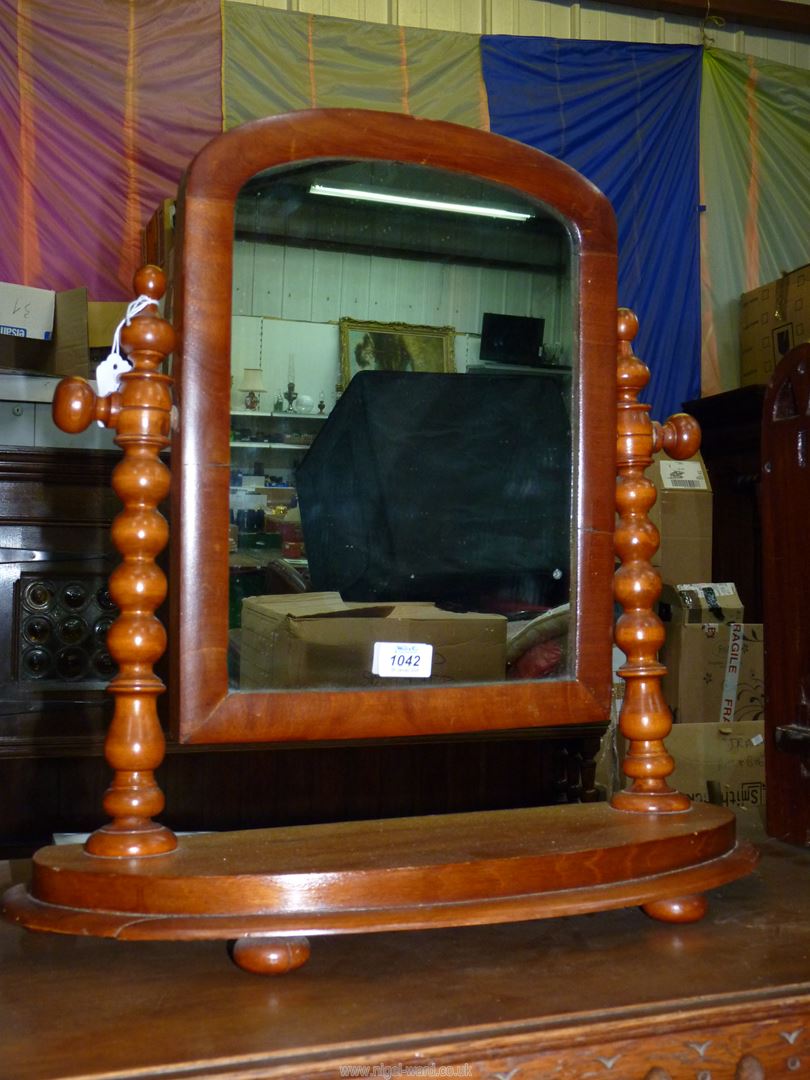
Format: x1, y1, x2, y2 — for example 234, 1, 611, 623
660, 582, 765, 724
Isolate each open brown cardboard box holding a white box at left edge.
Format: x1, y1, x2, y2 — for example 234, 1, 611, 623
0, 288, 91, 379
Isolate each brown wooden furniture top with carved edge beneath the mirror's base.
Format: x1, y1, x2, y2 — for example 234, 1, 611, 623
0, 816, 810, 1080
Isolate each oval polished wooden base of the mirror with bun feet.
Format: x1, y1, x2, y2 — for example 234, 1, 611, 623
3, 804, 757, 970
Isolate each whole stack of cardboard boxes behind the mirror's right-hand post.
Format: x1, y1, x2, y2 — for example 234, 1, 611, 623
603, 455, 765, 814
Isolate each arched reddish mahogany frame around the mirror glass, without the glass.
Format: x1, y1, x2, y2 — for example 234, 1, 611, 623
170, 109, 617, 743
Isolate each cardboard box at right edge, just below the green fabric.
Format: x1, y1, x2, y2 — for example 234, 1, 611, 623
740, 265, 810, 387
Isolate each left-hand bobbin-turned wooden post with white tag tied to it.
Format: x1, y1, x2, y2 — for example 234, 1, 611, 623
53, 266, 177, 859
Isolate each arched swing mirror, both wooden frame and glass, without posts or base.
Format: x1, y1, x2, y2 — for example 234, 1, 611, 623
171, 111, 616, 742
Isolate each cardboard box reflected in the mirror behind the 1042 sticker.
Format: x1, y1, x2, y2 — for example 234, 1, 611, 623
240, 593, 507, 689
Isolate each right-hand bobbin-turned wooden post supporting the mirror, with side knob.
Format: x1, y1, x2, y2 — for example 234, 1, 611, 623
611, 308, 700, 813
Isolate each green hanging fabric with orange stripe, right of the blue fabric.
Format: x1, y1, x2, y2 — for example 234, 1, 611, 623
700, 49, 810, 394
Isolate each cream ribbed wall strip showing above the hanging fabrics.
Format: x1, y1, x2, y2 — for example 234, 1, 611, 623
228, 0, 810, 68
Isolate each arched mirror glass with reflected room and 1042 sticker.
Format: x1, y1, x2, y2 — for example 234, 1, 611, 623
229, 161, 577, 690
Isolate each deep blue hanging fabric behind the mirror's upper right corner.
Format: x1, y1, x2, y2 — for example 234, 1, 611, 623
482, 37, 702, 420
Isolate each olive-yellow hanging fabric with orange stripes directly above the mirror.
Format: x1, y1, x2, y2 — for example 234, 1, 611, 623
222, 2, 489, 129
